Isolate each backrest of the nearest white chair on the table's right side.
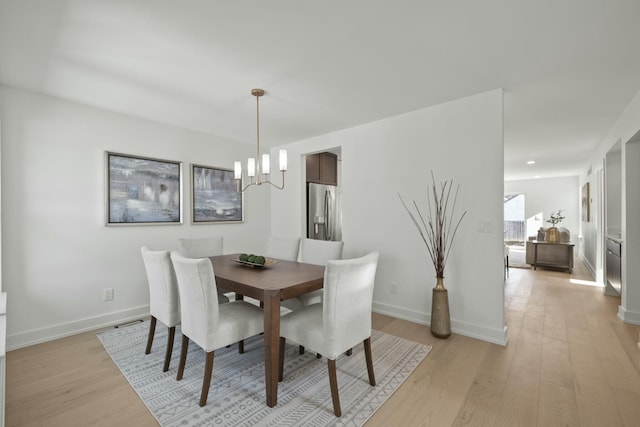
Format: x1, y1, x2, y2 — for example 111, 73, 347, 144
322, 251, 380, 350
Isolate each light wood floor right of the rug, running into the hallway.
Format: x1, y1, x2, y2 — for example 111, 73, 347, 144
366, 259, 640, 427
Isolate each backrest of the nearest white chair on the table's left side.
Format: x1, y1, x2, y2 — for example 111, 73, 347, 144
171, 251, 220, 348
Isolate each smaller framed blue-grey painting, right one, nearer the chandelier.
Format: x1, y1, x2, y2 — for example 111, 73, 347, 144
191, 165, 244, 224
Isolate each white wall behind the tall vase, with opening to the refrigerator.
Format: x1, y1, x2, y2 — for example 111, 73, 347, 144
271, 90, 507, 344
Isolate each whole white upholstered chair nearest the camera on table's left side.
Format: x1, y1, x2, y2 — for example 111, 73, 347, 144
171, 252, 264, 406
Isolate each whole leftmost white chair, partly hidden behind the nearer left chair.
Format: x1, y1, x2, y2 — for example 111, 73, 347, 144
140, 246, 180, 372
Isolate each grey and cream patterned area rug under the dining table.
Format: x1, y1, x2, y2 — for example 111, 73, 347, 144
97, 321, 431, 426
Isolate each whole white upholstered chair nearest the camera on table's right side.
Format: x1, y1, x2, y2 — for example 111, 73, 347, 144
279, 252, 379, 417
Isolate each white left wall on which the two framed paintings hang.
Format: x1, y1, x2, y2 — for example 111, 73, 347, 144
0, 87, 270, 349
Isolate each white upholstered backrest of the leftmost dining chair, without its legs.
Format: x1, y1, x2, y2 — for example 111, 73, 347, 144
140, 246, 180, 327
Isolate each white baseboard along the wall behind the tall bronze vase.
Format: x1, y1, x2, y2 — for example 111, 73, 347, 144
373, 301, 509, 346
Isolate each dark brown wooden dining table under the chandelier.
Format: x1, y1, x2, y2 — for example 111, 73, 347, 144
210, 254, 324, 407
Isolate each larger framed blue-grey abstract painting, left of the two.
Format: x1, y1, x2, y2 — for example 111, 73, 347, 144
105, 151, 182, 225
